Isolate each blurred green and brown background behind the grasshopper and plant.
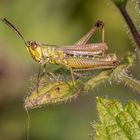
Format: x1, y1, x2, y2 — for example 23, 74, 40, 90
0, 0, 140, 140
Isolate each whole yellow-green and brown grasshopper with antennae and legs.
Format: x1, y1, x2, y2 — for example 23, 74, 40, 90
1, 18, 119, 90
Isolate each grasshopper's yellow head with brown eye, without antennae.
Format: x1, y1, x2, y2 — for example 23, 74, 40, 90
26, 41, 42, 62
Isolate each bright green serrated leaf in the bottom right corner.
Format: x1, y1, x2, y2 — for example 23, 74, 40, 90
95, 97, 140, 140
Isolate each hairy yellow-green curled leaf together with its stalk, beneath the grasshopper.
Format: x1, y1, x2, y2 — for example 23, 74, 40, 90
24, 71, 109, 109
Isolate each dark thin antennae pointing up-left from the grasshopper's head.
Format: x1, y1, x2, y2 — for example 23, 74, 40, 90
1, 18, 28, 46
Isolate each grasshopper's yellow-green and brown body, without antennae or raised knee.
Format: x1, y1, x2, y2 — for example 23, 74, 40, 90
27, 42, 118, 70
